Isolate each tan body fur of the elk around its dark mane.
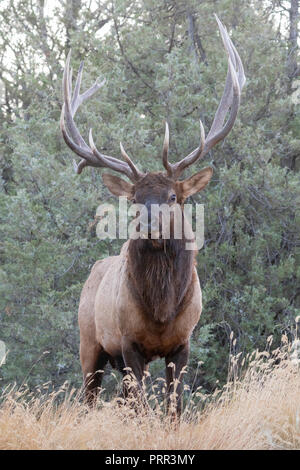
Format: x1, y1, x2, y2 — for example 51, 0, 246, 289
78, 241, 202, 375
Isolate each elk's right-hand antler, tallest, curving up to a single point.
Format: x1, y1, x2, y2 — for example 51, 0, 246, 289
162, 15, 246, 179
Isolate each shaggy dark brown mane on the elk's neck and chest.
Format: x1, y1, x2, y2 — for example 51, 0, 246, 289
128, 238, 196, 323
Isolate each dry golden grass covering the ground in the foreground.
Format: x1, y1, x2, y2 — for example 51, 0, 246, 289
0, 336, 300, 450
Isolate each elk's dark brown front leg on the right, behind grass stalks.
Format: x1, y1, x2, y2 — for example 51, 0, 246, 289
165, 343, 189, 415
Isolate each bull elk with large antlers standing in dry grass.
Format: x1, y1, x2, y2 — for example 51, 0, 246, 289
60, 17, 245, 412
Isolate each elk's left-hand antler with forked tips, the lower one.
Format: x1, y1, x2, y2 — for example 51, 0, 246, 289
60, 51, 144, 182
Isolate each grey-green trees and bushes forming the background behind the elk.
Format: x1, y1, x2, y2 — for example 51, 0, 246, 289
0, 0, 300, 391
